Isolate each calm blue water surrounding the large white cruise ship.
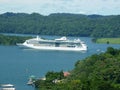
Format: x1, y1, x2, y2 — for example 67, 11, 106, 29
0, 36, 120, 90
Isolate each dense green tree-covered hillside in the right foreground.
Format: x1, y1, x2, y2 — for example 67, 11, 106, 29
35, 47, 120, 90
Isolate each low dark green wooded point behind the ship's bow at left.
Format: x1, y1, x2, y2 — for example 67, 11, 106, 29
0, 35, 31, 45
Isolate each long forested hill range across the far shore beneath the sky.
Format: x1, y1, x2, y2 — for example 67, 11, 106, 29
0, 13, 120, 37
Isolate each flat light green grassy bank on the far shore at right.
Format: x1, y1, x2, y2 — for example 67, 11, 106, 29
95, 38, 120, 44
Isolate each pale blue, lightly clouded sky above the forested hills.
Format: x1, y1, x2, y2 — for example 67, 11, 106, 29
0, 0, 120, 15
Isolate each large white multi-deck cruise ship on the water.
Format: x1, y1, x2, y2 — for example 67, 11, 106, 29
17, 36, 87, 51
